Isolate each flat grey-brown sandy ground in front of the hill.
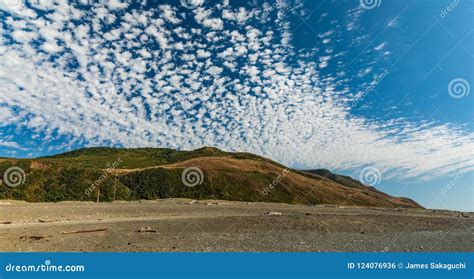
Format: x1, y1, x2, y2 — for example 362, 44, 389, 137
0, 199, 474, 252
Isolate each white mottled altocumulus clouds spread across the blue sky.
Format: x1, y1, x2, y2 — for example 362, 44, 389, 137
0, 0, 474, 182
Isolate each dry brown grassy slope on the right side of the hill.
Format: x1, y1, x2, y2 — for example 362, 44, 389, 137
109, 157, 420, 208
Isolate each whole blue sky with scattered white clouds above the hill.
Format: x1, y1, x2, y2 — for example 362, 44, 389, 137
0, 0, 474, 211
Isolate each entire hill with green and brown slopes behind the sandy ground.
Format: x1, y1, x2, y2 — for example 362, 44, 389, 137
0, 147, 419, 207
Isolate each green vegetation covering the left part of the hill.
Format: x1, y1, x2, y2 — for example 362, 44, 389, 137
0, 147, 271, 202
